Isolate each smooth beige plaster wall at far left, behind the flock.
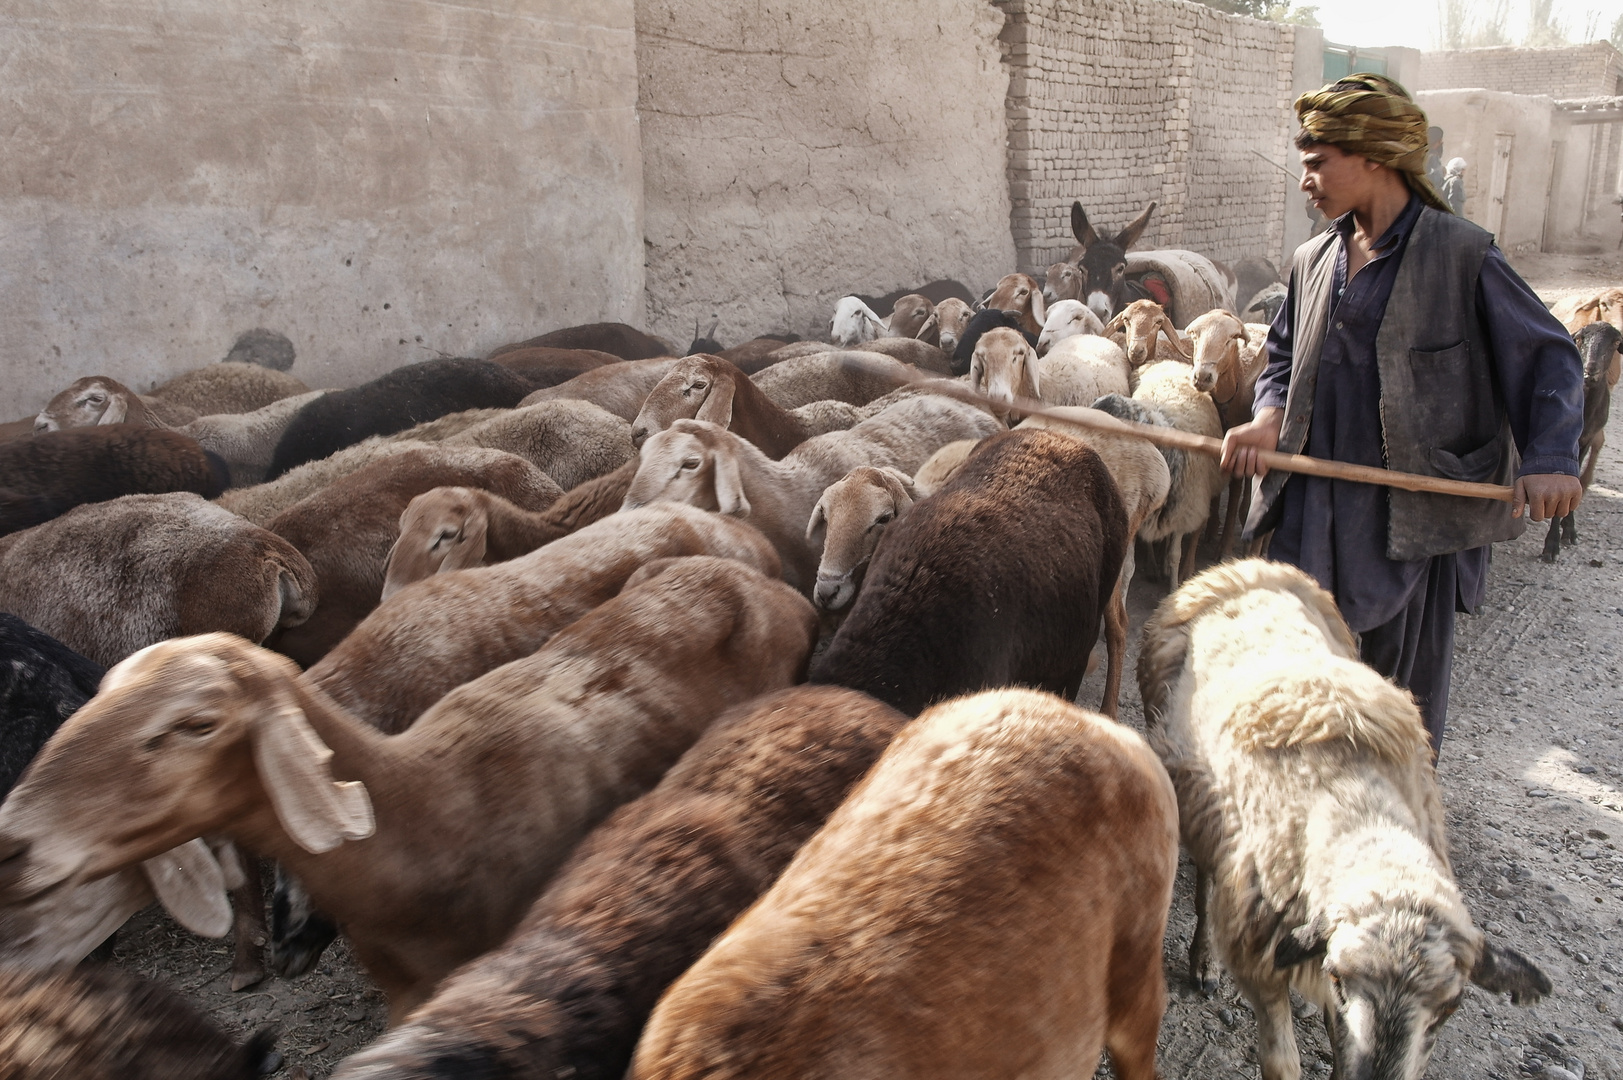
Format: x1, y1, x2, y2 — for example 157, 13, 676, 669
0, 0, 643, 412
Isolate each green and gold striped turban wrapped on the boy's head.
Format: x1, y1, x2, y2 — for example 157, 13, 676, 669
1297, 73, 1453, 213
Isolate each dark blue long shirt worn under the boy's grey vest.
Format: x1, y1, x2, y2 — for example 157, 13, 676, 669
1255, 197, 1584, 632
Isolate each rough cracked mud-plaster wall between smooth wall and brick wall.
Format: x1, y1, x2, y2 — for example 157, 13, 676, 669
636, 0, 1014, 343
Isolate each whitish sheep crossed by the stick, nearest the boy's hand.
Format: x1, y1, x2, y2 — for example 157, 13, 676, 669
1123, 361, 1224, 588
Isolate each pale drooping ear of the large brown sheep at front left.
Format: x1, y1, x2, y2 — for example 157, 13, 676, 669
253, 690, 377, 854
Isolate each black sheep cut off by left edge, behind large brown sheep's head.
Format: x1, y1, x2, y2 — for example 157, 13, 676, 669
0, 612, 102, 799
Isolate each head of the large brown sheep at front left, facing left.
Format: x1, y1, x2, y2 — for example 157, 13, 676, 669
0, 633, 373, 905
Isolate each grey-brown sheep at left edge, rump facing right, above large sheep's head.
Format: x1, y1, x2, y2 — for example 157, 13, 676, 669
0, 492, 316, 667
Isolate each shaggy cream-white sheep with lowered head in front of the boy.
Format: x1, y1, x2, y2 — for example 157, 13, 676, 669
1138, 559, 1550, 1080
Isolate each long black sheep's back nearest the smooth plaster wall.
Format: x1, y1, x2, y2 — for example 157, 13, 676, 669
265, 357, 532, 481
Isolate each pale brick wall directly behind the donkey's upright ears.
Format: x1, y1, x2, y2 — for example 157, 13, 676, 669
993, 0, 1295, 270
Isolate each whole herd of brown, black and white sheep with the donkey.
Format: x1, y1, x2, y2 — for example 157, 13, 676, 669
0, 204, 1623, 1080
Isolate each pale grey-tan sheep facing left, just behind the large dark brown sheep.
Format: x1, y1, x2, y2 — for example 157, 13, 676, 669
625, 395, 1000, 594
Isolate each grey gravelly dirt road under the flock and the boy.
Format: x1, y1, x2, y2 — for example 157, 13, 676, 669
115, 257, 1623, 1080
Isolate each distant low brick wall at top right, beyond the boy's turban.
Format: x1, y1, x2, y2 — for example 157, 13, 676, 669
1414, 41, 1623, 97
